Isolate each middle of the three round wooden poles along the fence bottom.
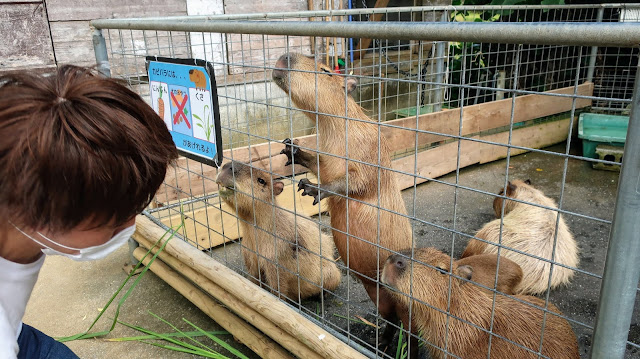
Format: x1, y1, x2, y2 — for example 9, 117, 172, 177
133, 235, 322, 359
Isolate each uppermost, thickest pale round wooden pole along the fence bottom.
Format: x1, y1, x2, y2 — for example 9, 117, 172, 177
136, 216, 366, 359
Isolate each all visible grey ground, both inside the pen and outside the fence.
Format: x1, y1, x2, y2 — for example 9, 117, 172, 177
25, 144, 640, 358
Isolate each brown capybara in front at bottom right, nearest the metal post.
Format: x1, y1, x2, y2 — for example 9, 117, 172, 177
382, 248, 580, 359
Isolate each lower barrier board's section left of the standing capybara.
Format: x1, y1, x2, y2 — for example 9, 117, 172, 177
162, 174, 326, 248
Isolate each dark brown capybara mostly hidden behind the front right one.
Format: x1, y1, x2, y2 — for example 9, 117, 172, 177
455, 254, 522, 295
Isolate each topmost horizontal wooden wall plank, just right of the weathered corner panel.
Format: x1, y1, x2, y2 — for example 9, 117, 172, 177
47, 0, 187, 21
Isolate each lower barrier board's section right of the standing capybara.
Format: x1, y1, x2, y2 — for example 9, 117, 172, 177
393, 119, 577, 189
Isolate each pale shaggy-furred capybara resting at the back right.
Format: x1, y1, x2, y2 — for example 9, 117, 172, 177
462, 180, 579, 295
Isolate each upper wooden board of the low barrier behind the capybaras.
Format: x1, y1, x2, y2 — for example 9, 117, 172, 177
158, 83, 593, 202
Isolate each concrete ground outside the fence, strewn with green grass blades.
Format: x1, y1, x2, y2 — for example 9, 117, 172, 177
24, 245, 258, 359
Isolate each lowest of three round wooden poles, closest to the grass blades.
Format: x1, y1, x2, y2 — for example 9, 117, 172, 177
133, 247, 293, 359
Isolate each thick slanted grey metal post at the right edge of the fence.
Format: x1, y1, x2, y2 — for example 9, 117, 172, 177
591, 57, 640, 359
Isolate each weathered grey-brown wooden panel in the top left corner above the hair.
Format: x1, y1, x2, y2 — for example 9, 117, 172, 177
0, 2, 55, 72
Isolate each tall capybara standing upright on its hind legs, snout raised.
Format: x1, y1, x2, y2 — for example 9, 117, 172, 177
272, 53, 412, 345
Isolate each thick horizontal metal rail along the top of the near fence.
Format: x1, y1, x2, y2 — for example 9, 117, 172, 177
91, 19, 640, 47
